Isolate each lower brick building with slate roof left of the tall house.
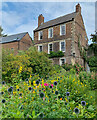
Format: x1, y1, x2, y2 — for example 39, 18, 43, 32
0, 32, 33, 54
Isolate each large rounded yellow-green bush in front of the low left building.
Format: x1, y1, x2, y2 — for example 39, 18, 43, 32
2, 47, 53, 82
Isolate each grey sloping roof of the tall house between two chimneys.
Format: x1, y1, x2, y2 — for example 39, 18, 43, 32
34, 12, 76, 31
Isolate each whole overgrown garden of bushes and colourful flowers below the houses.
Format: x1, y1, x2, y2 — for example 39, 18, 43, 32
0, 48, 97, 118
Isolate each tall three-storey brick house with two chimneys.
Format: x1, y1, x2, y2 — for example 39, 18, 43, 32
34, 4, 88, 66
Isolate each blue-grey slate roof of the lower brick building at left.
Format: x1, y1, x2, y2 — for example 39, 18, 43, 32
0, 32, 28, 43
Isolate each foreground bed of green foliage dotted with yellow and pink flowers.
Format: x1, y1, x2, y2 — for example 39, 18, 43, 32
0, 71, 97, 119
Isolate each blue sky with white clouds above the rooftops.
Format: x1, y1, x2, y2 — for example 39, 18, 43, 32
0, 2, 95, 44
